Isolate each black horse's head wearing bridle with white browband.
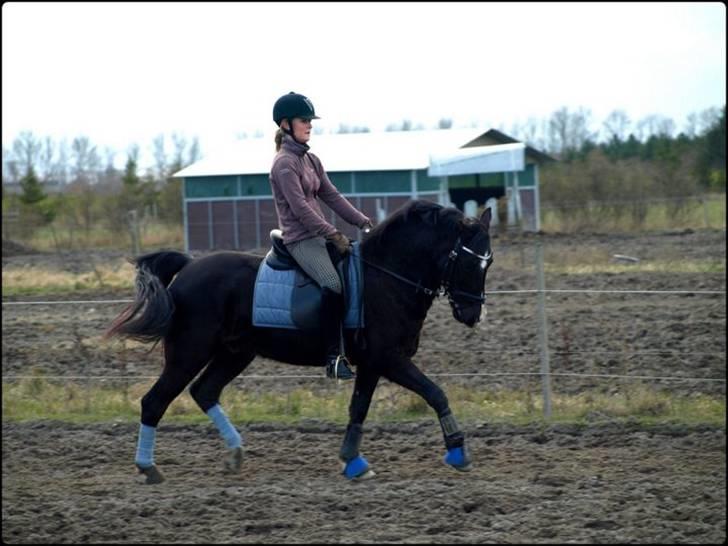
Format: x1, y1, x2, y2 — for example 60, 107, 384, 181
443, 208, 493, 328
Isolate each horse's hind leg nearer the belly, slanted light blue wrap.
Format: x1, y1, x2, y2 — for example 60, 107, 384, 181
190, 348, 255, 472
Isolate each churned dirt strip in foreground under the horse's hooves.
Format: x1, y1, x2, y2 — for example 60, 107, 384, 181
2, 416, 726, 544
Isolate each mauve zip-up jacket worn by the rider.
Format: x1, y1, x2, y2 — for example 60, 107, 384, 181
270, 135, 369, 245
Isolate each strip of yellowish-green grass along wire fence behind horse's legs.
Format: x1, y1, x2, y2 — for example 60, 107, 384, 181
2, 375, 726, 426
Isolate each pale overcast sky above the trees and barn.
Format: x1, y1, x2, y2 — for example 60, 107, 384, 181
2, 2, 726, 168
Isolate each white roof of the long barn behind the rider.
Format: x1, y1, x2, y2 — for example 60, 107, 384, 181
174, 128, 549, 177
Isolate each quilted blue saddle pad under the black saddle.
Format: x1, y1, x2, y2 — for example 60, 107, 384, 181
253, 242, 364, 330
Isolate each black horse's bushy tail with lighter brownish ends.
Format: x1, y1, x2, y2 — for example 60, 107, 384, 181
105, 250, 192, 343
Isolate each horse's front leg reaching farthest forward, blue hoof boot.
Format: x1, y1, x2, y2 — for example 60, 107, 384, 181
384, 358, 472, 472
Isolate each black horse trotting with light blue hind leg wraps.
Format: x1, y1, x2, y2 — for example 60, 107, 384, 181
106, 200, 493, 484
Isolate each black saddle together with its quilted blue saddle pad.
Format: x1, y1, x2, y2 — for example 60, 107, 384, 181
253, 229, 364, 330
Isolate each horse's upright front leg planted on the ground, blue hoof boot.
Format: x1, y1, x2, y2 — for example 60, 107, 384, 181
339, 367, 379, 480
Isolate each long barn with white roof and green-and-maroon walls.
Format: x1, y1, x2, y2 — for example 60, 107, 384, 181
175, 129, 552, 251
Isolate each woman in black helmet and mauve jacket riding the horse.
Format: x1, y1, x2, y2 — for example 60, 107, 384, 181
270, 91, 372, 379
